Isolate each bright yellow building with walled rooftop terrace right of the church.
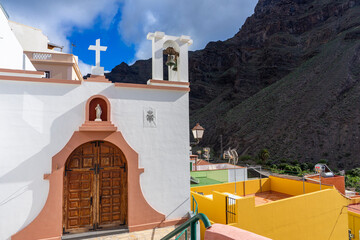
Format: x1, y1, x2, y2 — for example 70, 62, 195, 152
191, 176, 350, 240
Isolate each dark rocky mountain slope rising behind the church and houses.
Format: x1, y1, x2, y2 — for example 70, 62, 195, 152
107, 0, 360, 169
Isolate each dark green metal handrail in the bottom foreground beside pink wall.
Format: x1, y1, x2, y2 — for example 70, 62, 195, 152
161, 213, 211, 240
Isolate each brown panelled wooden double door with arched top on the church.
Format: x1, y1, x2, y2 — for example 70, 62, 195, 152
63, 141, 128, 233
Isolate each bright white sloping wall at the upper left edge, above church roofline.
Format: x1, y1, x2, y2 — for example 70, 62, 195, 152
0, 10, 35, 70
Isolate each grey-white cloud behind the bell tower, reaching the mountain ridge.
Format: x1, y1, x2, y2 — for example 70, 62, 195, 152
118, 0, 257, 59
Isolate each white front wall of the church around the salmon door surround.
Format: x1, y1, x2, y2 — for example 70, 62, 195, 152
0, 81, 190, 239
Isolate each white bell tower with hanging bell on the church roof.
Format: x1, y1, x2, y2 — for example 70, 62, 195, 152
147, 32, 193, 82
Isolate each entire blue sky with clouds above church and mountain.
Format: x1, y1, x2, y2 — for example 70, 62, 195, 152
0, 0, 257, 75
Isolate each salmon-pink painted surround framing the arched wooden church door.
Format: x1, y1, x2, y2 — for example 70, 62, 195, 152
12, 131, 167, 240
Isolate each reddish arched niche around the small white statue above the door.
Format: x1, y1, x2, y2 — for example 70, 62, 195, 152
85, 95, 111, 122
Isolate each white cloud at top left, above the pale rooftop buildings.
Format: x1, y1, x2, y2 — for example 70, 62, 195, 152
2, 0, 121, 51
